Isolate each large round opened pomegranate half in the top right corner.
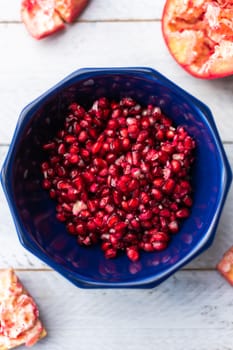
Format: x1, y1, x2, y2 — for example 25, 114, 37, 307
162, 0, 233, 79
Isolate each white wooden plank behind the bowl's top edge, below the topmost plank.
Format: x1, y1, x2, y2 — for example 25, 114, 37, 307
0, 22, 233, 143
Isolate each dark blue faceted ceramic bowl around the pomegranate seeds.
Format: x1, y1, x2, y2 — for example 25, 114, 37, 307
1, 68, 232, 288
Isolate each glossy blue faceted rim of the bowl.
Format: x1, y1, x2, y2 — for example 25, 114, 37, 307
0, 67, 232, 288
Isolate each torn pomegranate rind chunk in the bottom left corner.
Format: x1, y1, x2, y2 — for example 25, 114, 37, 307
0, 269, 47, 350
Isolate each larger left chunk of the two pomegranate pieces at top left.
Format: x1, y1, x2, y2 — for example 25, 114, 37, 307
21, 0, 65, 40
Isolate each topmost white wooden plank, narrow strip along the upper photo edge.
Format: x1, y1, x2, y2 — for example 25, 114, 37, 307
0, 0, 164, 22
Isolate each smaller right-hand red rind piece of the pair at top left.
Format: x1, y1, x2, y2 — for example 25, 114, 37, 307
55, 0, 89, 23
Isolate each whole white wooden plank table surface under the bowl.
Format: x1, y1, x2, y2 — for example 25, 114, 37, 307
0, 0, 233, 350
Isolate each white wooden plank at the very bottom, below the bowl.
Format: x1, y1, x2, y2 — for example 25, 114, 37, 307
8, 271, 233, 350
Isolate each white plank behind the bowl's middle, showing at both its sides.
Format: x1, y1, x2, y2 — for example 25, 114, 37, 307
0, 144, 233, 269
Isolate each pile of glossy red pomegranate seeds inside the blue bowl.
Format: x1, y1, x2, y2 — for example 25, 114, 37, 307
41, 97, 195, 261
